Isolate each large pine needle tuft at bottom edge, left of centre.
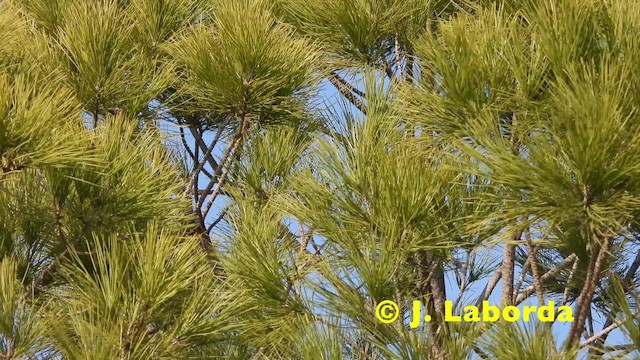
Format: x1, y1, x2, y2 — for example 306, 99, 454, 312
51, 224, 244, 359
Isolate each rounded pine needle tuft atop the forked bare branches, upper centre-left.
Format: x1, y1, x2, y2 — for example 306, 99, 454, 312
168, 1, 318, 122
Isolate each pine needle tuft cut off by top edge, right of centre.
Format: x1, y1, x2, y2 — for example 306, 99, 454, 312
274, 0, 453, 68
